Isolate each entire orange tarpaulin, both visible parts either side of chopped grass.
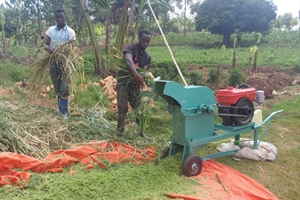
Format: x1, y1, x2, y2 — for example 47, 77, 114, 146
0, 141, 277, 200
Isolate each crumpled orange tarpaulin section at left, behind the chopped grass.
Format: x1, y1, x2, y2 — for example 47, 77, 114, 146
0, 141, 156, 187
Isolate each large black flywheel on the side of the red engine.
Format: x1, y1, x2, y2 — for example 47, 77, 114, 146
233, 98, 254, 125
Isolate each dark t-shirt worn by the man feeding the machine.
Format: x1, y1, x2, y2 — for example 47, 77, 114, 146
117, 43, 151, 83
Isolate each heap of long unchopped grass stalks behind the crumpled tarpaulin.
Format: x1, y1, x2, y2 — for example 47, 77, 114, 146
0, 101, 154, 159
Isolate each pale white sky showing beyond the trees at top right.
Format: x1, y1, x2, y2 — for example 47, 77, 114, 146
0, 0, 300, 17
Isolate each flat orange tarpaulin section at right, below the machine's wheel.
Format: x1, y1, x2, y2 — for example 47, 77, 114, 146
167, 160, 277, 200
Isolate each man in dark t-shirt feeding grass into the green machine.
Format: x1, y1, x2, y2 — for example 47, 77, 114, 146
117, 30, 152, 137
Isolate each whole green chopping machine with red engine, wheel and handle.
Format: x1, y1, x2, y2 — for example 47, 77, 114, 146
152, 80, 283, 176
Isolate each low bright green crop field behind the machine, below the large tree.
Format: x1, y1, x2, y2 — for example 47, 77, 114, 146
147, 38, 300, 69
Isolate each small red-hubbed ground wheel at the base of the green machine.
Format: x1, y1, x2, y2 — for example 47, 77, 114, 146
182, 155, 202, 177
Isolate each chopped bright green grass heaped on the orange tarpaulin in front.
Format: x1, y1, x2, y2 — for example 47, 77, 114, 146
0, 156, 199, 200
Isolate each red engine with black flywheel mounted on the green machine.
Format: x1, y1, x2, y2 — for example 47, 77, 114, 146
217, 87, 256, 126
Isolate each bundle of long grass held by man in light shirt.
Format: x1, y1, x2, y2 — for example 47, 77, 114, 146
29, 42, 83, 98
